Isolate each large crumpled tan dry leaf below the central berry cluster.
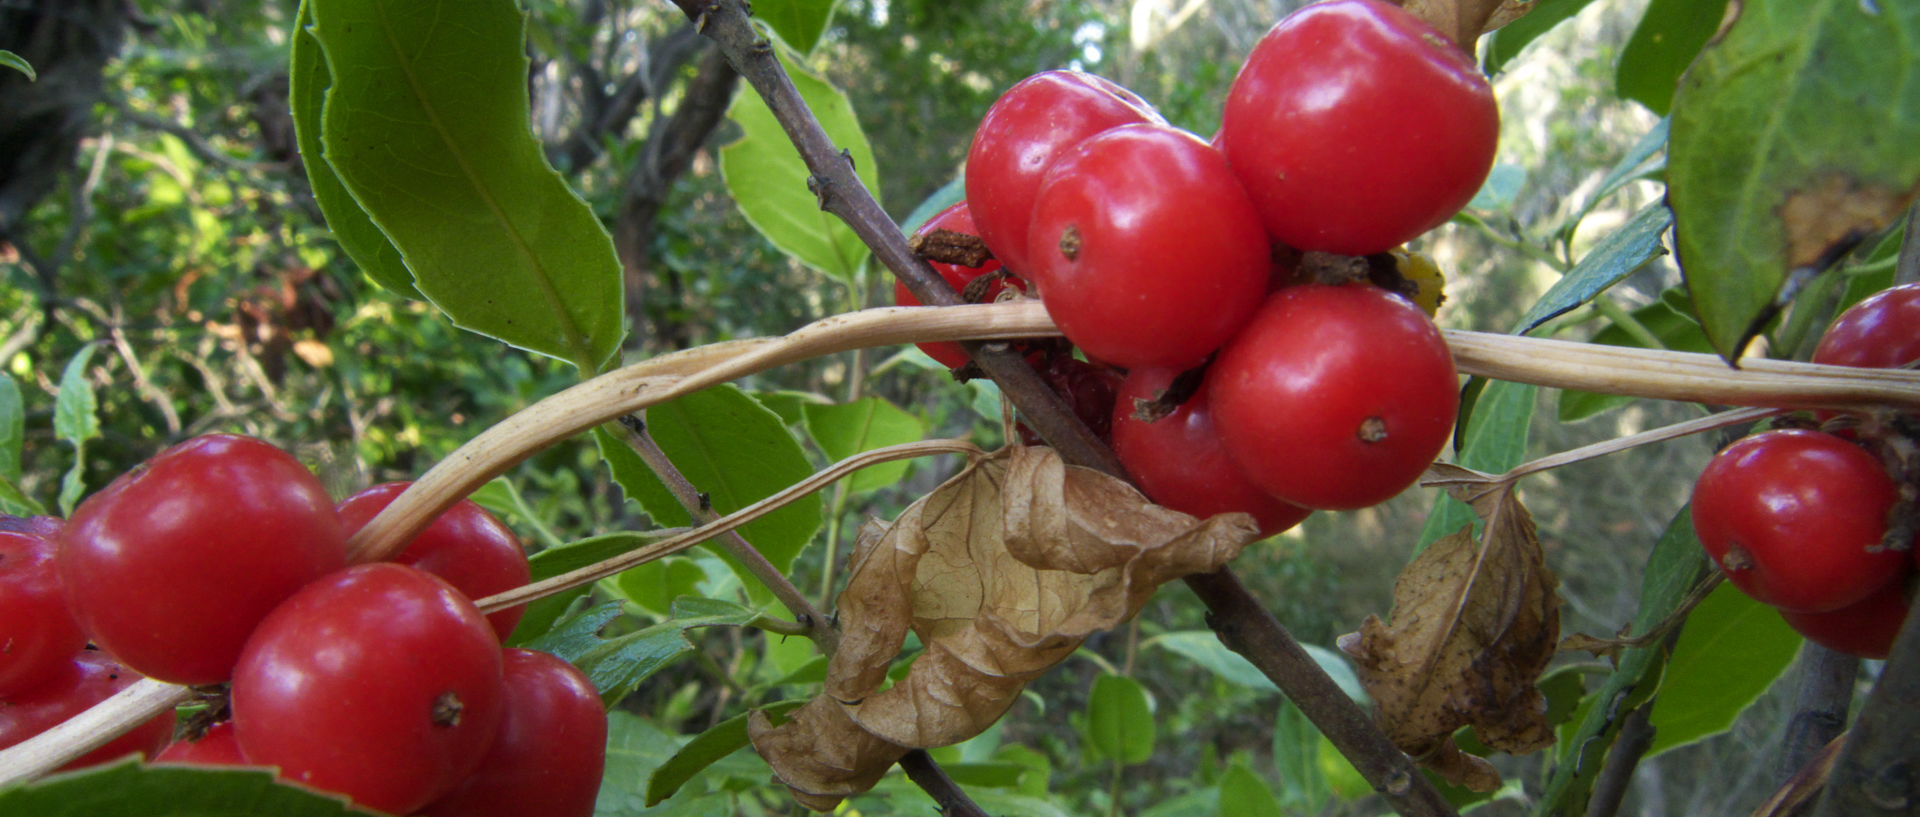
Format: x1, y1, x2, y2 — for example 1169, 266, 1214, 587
751, 447, 1260, 811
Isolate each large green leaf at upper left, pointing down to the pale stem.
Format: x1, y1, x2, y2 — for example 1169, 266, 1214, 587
309, 0, 624, 374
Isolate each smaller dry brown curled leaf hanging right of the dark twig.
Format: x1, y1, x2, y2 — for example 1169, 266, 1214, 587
1340, 466, 1559, 792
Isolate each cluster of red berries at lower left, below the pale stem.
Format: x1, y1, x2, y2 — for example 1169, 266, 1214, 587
0, 435, 607, 817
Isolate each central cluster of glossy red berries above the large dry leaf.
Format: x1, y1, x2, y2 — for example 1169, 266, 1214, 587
899, 0, 1500, 533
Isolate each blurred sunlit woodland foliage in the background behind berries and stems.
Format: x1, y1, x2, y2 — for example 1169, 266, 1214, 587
0, 0, 1827, 815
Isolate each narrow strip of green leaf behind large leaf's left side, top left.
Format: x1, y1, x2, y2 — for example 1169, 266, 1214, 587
288, 0, 426, 301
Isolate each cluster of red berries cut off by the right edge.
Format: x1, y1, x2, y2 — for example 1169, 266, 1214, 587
1693, 284, 1920, 658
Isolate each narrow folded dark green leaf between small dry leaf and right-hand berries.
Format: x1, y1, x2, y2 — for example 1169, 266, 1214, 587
1534, 508, 1707, 817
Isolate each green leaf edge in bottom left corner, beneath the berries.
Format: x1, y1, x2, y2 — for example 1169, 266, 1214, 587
0, 761, 371, 817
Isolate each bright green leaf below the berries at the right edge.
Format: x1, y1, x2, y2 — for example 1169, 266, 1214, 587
1647, 583, 1801, 758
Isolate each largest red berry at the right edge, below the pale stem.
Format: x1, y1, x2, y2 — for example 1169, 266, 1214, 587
1693, 430, 1910, 612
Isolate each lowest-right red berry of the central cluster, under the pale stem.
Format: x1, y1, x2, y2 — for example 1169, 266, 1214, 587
1208, 284, 1459, 510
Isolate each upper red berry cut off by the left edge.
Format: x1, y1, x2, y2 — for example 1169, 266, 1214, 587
0, 531, 86, 698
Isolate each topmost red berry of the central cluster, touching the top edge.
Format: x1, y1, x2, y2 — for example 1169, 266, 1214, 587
1219, 0, 1500, 255
